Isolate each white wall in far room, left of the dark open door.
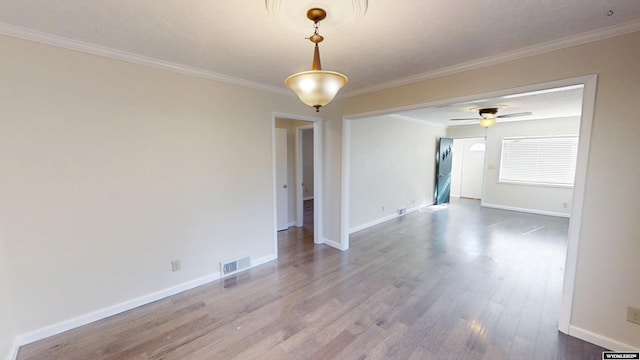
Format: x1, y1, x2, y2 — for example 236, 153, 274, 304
349, 116, 446, 230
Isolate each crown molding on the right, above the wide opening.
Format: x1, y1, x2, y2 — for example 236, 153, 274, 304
342, 20, 640, 98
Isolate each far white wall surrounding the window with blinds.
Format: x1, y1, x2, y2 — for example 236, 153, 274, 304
447, 117, 580, 216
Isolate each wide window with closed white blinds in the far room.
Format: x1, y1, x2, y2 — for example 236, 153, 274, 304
499, 135, 578, 187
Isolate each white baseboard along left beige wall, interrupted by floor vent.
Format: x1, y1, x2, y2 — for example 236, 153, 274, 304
10, 255, 277, 352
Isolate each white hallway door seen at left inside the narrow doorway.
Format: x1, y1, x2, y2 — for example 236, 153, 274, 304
276, 128, 289, 231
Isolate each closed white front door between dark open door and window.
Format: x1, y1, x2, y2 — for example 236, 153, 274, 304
460, 139, 485, 199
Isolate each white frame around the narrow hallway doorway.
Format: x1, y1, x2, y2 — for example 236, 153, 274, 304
271, 112, 324, 253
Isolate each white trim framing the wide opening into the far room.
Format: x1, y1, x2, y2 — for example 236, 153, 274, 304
340, 74, 598, 335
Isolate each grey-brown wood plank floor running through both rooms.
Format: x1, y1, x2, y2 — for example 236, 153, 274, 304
18, 200, 604, 360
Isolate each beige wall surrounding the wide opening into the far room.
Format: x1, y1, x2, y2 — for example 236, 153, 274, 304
326, 32, 640, 348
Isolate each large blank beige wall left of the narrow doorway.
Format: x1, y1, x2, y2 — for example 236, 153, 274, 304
0, 30, 312, 355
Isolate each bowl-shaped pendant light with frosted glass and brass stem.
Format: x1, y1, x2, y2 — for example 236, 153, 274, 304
284, 8, 349, 112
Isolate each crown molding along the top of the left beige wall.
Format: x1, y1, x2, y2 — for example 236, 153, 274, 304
0, 22, 292, 95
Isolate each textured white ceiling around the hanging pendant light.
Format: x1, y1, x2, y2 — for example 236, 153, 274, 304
0, 0, 640, 118
